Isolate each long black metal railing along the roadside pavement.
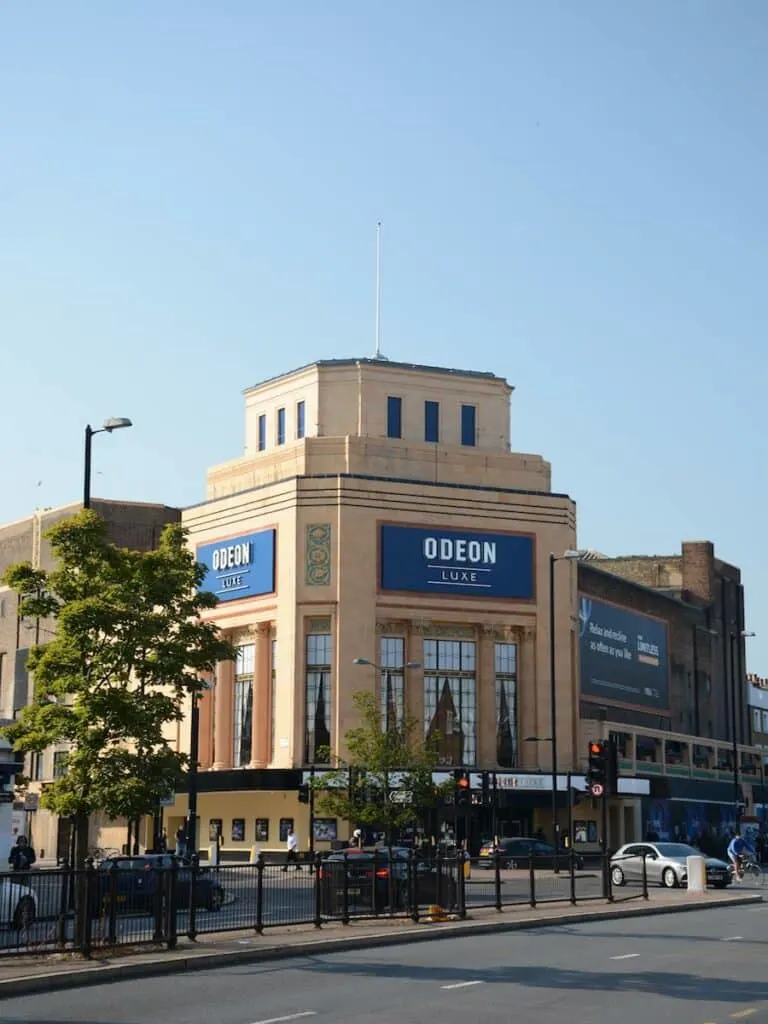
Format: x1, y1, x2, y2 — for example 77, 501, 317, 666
0, 848, 648, 956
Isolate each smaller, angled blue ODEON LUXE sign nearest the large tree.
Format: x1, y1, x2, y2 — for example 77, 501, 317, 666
198, 529, 275, 601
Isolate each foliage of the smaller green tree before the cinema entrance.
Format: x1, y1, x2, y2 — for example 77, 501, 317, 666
312, 690, 453, 842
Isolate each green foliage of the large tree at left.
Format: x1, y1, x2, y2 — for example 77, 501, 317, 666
3, 510, 234, 818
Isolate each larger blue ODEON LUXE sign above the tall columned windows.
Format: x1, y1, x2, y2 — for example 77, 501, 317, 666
380, 524, 534, 601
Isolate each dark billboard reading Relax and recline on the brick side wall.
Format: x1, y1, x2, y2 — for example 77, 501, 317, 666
579, 594, 670, 711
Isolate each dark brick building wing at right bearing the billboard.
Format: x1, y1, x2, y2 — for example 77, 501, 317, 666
579, 542, 762, 842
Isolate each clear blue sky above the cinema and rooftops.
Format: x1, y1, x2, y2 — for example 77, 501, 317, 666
0, 0, 768, 673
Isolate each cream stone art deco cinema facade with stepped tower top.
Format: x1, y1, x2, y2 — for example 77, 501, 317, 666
167, 359, 579, 852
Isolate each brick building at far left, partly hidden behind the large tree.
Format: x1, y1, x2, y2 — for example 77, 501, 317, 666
0, 500, 181, 856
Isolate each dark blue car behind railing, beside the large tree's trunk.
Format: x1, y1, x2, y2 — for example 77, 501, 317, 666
94, 853, 224, 913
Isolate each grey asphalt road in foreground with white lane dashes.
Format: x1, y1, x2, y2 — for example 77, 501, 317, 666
0, 904, 768, 1024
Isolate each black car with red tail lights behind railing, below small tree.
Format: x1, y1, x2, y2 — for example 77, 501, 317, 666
317, 847, 460, 916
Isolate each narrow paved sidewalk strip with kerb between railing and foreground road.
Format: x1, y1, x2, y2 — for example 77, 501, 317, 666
0, 891, 762, 999
